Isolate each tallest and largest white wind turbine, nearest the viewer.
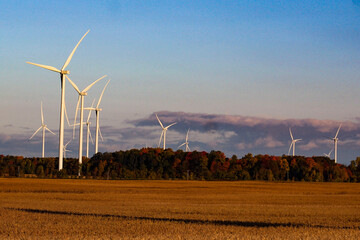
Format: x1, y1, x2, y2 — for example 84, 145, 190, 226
26, 30, 90, 170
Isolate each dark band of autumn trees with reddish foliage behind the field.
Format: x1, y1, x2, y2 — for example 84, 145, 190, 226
0, 148, 360, 182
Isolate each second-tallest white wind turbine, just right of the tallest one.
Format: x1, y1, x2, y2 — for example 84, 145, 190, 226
66, 75, 106, 164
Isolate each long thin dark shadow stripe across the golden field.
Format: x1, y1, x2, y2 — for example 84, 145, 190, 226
4, 207, 360, 229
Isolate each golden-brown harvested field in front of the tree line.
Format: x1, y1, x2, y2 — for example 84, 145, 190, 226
0, 178, 360, 239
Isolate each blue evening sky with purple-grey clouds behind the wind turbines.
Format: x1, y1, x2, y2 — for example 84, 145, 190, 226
0, 0, 360, 164
